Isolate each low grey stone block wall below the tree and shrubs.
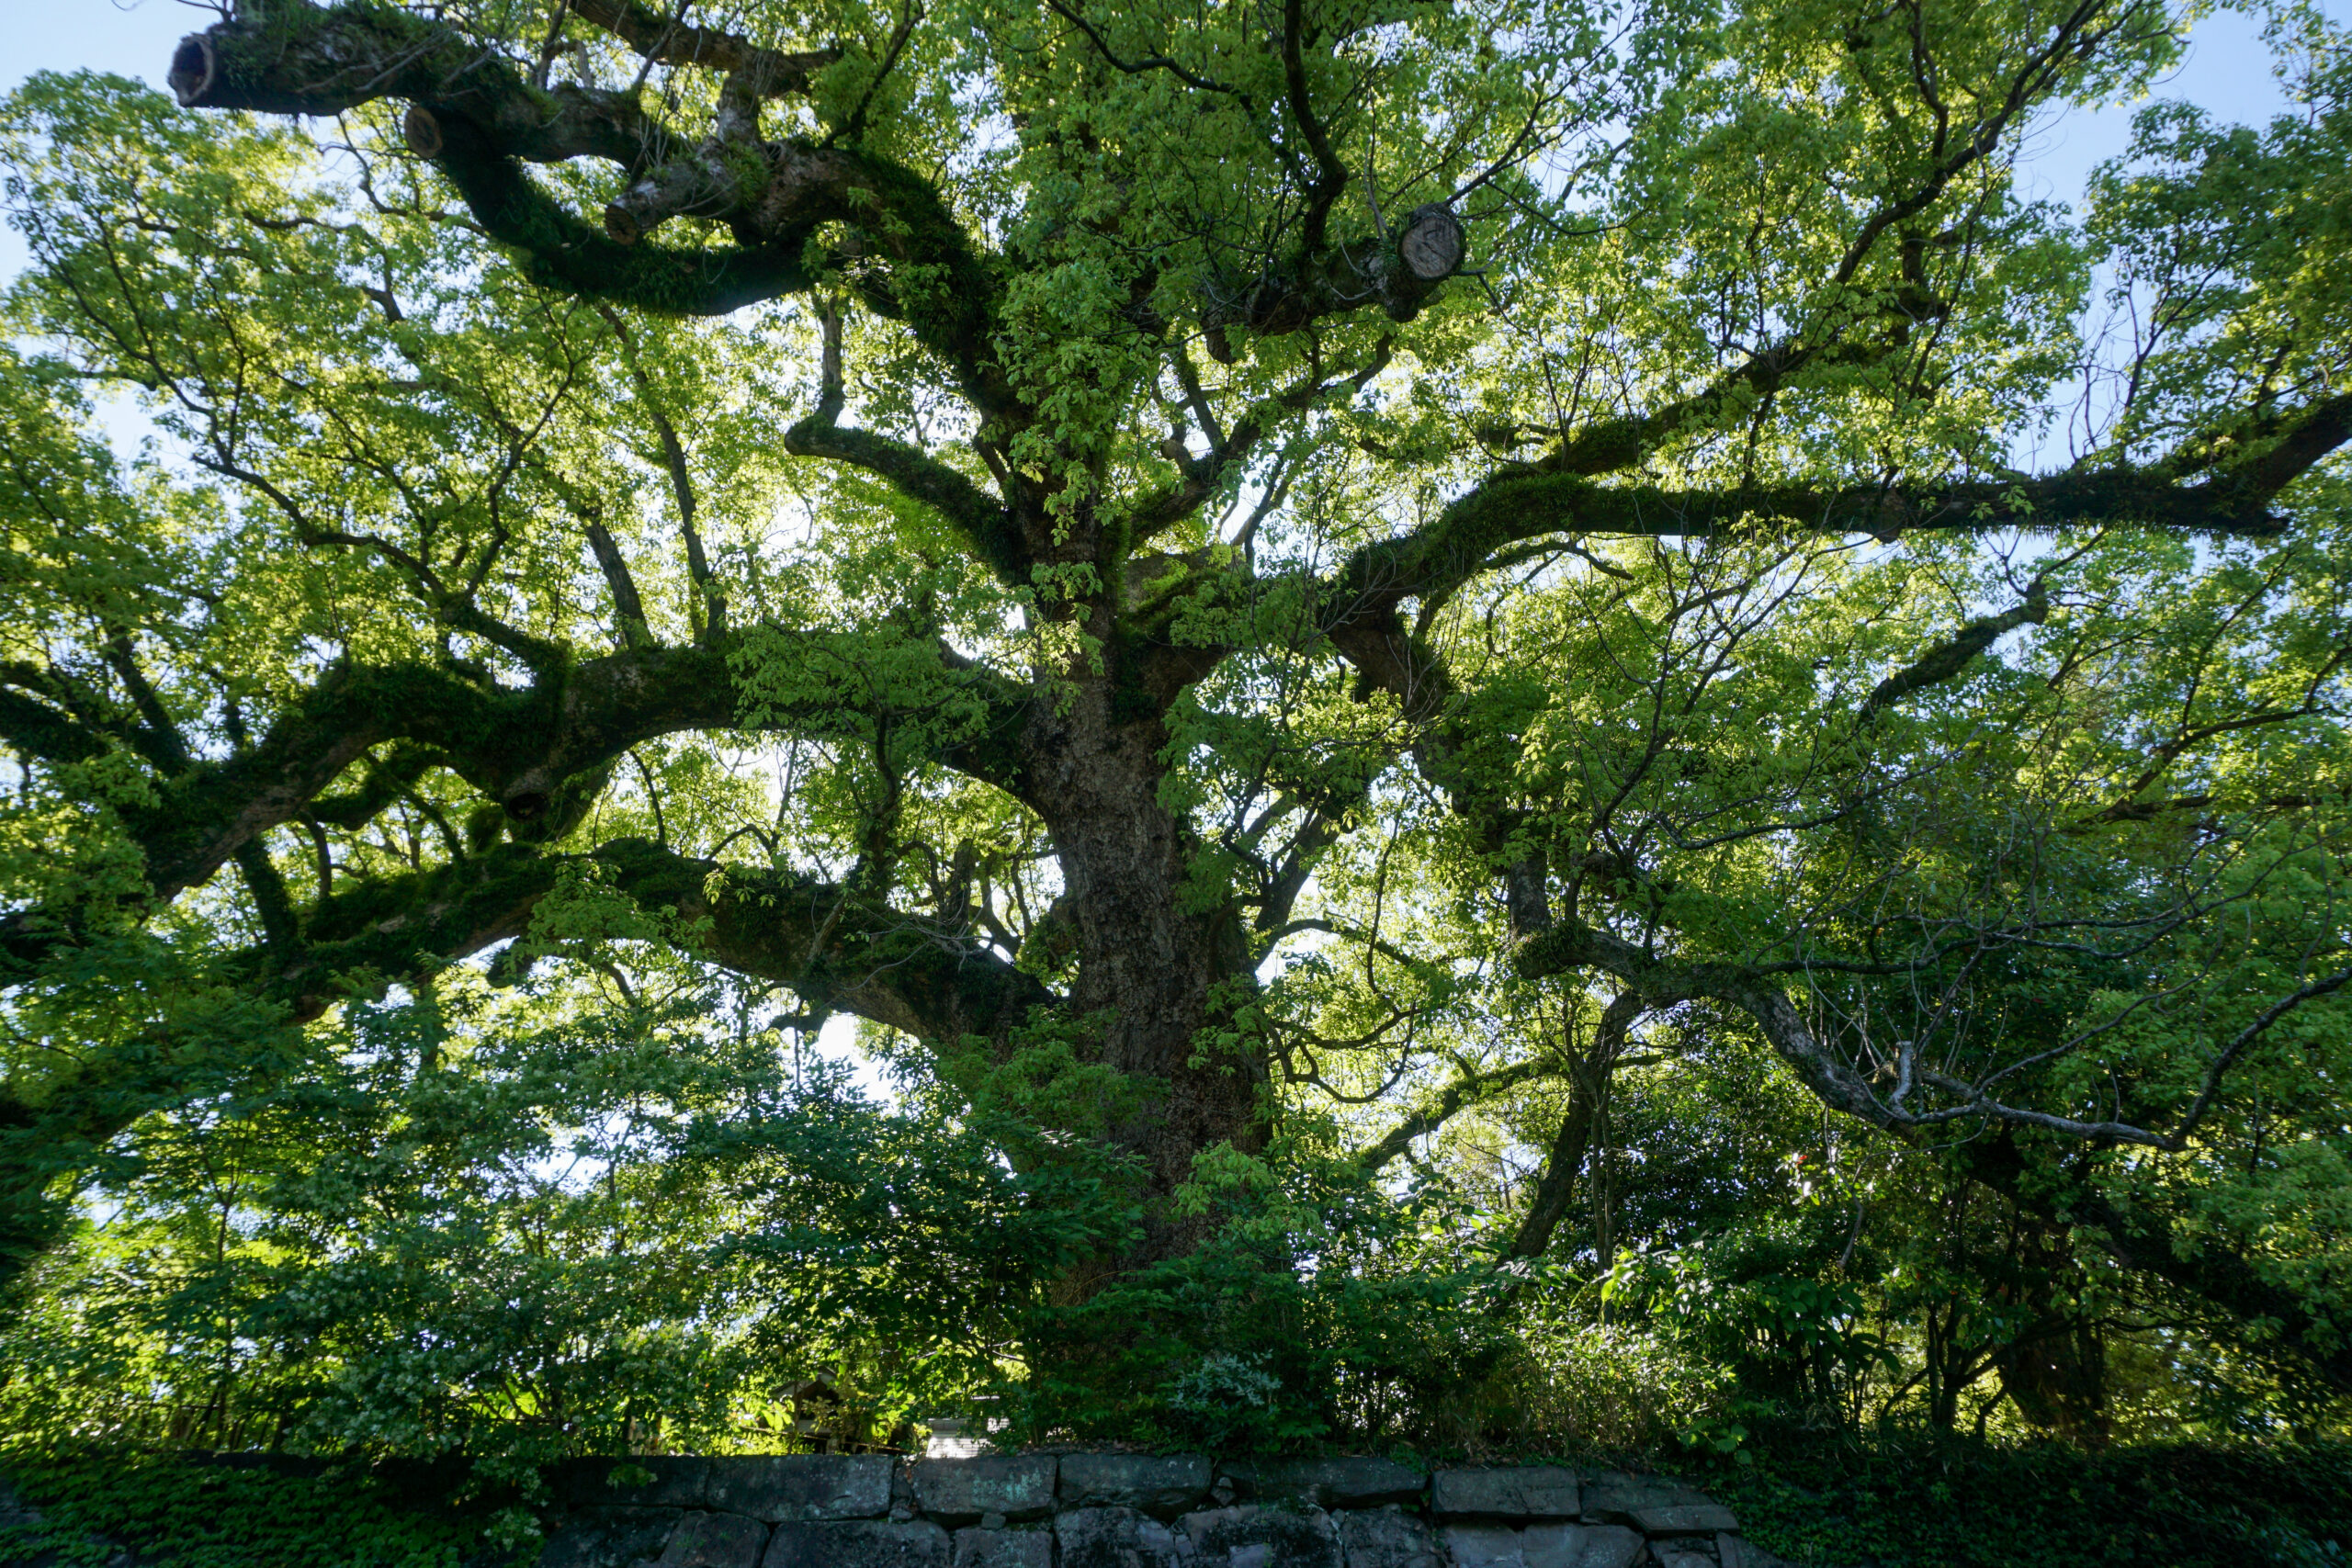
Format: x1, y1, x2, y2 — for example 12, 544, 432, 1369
538, 1453, 1782, 1568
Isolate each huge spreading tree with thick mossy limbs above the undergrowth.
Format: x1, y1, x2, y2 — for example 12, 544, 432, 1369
0, 0, 2352, 1387
